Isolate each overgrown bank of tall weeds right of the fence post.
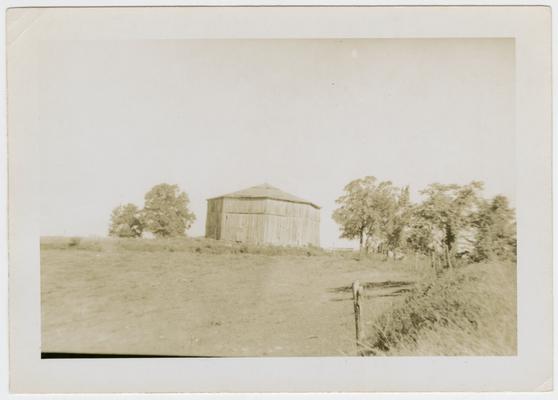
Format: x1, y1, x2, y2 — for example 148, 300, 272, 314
366, 263, 517, 356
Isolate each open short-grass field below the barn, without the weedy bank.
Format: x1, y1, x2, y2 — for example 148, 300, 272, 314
41, 238, 515, 356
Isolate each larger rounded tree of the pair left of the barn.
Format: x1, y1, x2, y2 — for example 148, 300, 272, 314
142, 183, 196, 237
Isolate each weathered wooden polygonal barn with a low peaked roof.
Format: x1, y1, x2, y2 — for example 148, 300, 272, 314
205, 184, 320, 246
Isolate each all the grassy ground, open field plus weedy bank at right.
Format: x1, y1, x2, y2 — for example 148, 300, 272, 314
41, 237, 516, 356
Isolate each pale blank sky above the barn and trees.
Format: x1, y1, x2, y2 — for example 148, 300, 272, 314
36, 39, 515, 247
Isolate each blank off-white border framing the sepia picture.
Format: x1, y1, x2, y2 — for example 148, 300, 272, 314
6, 3, 553, 393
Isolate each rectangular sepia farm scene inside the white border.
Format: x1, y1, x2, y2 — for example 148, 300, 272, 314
34, 39, 516, 358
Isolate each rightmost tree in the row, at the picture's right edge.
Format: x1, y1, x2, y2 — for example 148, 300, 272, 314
473, 195, 517, 261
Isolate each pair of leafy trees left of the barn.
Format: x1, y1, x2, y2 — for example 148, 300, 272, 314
109, 183, 196, 238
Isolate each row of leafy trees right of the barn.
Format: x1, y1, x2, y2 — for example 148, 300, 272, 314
333, 176, 517, 266
